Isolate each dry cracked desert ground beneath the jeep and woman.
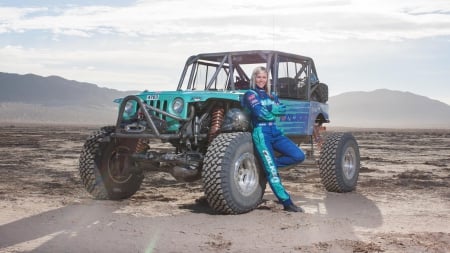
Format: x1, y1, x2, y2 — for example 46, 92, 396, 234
0, 124, 450, 253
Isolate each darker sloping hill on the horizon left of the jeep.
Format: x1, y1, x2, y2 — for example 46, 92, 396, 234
0, 72, 137, 124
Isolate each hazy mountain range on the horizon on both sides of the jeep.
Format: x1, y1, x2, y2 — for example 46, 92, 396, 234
0, 72, 450, 129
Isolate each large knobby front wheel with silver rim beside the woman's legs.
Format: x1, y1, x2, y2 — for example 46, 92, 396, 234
202, 132, 267, 214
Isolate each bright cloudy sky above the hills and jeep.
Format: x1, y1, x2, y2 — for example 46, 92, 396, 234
0, 0, 450, 105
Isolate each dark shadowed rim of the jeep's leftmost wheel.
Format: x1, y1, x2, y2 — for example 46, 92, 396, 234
108, 146, 132, 184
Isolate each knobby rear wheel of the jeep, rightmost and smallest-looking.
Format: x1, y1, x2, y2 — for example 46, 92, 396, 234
319, 133, 360, 192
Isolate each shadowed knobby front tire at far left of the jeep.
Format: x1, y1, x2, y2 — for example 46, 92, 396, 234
79, 126, 144, 200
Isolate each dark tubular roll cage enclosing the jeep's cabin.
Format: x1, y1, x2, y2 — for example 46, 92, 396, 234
177, 50, 319, 100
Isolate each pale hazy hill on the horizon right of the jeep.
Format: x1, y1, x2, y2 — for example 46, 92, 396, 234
329, 89, 450, 129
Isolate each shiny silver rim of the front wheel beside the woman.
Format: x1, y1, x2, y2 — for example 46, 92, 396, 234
234, 153, 258, 196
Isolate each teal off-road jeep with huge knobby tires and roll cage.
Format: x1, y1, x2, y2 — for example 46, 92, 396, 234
79, 50, 360, 214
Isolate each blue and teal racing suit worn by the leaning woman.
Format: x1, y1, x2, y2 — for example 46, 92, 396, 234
242, 88, 305, 206
